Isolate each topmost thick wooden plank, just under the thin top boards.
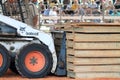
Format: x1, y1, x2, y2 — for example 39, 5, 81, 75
74, 26, 120, 33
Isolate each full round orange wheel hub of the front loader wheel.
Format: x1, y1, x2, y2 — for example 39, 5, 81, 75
25, 51, 45, 72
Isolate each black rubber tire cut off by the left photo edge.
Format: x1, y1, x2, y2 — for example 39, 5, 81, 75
0, 44, 10, 76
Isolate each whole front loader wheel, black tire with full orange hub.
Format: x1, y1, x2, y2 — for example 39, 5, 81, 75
16, 43, 52, 78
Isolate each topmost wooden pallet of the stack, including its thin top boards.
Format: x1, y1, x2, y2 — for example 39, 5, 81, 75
55, 22, 120, 33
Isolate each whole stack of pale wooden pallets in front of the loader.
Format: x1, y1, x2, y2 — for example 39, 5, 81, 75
64, 23, 120, 78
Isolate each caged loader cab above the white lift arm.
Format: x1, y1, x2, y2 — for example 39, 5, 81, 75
0, 0, 40, 28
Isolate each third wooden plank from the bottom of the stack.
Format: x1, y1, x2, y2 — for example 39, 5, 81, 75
67, 55, 120, 65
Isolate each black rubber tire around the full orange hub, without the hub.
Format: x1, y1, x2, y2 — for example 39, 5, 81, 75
15, 43, 53, 78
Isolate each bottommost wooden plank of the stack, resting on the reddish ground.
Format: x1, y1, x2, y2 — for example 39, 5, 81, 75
67, 71, 120, 79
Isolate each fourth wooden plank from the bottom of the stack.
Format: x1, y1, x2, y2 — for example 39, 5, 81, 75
74, 50, 120, 58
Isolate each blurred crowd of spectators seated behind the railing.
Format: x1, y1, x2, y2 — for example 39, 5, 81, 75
34, 0, 120, 16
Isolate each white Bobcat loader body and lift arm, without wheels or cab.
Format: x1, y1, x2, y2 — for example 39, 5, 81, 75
0, 14, 57, 73
